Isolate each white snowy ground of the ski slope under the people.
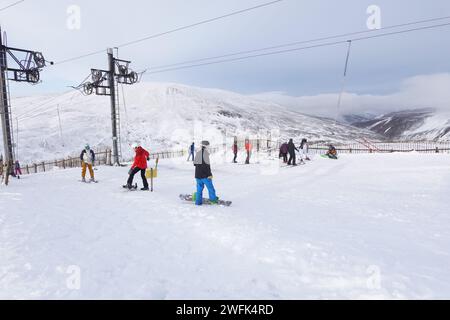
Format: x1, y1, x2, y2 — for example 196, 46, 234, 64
0, 154, 450, 299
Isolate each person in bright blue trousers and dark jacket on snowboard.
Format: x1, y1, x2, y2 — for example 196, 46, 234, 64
194, 141, 219, 206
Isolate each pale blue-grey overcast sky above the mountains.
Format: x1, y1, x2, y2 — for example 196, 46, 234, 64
0, 0, 450, 100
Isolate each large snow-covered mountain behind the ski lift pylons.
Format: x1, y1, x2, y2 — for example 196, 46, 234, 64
6, 83, 380, 162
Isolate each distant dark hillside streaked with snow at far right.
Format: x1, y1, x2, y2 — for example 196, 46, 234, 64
351, 109, 450, 141
